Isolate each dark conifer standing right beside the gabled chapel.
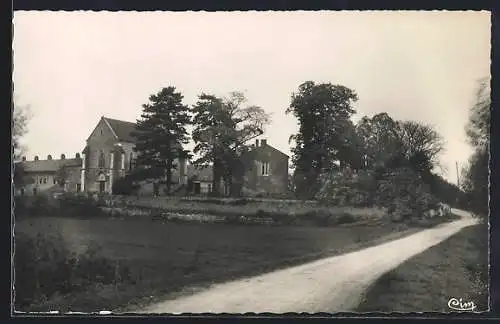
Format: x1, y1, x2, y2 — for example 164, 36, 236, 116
132, 86, 191, 194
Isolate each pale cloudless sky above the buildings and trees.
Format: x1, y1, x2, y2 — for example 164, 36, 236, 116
13, 11, 491, 183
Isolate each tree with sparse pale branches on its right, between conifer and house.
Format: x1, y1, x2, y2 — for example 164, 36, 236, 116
192, 91, 271, 196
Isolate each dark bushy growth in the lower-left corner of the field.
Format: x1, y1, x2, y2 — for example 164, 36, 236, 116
14, 234, 133, 309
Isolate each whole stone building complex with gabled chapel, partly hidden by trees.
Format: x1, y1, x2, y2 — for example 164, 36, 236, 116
14, 116, 288, 195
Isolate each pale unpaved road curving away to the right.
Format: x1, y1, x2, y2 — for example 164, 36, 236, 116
140, 209, 475, 314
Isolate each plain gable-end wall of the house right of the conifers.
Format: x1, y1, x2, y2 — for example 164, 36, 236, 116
243, 146, 288, 194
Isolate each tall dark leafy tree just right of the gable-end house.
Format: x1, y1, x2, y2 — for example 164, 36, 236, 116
286, 81, 358, 198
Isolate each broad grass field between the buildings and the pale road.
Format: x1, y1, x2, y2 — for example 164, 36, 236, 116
15, 217, 418, 312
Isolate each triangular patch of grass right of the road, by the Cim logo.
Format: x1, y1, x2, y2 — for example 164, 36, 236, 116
357, 225, 488, 312
